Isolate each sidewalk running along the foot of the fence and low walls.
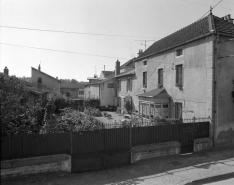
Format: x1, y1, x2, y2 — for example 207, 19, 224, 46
1, 147, 234, 185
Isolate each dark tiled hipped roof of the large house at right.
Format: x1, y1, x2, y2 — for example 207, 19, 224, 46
137, 14, 234, 60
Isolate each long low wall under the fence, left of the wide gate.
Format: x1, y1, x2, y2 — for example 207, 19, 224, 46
1, 154, 71, 177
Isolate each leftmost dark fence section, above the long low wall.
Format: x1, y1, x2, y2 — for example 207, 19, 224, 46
1, 133, 71, 160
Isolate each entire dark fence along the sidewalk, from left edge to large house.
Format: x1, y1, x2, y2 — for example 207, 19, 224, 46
1, 122, 209, 160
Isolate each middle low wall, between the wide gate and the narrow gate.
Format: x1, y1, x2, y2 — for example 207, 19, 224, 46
131, 141, 181, 163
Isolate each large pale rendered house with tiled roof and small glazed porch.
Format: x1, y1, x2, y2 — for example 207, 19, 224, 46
133, 13, 234, 144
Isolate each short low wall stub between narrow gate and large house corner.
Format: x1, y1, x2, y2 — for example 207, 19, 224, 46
193, 138, 213, 152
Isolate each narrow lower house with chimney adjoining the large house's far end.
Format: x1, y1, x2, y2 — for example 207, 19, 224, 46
115, 58, 136, 113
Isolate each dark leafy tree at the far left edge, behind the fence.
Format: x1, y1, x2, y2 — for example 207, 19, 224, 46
0, 73, 27, 131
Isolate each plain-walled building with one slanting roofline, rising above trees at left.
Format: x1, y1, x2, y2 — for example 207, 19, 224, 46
31, 65, 61, 92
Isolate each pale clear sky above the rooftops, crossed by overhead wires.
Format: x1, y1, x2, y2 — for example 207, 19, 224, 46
0, 0, 234, 81
